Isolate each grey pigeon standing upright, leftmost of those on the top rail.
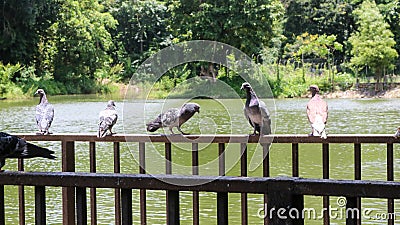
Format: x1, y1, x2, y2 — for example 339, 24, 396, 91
35, 89, 54, 135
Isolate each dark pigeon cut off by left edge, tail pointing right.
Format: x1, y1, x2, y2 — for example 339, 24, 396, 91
0, 132, 56, 171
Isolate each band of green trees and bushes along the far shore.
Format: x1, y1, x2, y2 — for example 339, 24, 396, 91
0, 0, 400, 97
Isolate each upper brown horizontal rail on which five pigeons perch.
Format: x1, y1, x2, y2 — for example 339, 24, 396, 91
10, 133, 400, 143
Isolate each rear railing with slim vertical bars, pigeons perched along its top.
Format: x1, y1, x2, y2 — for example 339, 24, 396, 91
0, 134, 400, 225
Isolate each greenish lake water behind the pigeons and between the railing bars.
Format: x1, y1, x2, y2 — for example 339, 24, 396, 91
0, 96, 400, 224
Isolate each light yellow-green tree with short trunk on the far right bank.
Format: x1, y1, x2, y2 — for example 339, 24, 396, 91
349, 1, 398, 91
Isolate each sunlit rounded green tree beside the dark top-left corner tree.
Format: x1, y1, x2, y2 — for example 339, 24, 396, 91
42, 0, 117, 86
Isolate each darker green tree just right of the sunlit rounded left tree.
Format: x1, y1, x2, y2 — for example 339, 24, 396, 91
109, 0, 169, 78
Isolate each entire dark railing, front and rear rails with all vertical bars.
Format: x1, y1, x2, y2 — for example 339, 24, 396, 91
0, 134, 400, 224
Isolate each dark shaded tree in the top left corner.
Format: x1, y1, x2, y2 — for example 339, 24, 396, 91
0, 0, 57, 65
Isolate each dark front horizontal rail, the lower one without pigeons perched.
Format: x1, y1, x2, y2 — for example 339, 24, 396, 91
0, 171, 400, 199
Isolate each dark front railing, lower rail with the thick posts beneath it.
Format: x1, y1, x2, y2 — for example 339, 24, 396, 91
0, 172, 400, 225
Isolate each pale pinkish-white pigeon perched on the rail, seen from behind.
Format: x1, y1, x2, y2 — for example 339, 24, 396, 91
307, 85, 328, 139
